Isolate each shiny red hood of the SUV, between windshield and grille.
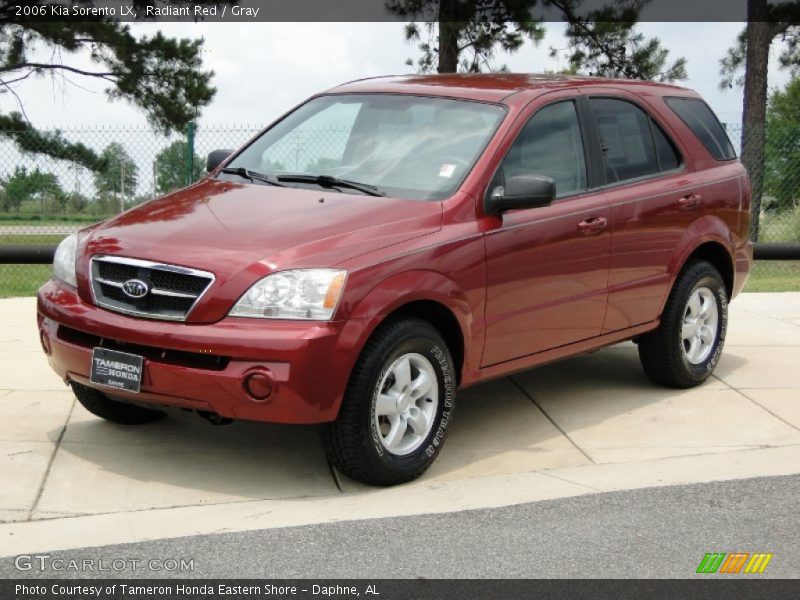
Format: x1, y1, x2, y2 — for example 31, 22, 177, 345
80, 179, 442, 320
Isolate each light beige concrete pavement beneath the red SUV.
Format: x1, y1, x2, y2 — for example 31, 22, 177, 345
0, 293, 800, 555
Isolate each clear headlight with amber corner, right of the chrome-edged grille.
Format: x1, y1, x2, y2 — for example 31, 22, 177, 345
229, 269, 347, 321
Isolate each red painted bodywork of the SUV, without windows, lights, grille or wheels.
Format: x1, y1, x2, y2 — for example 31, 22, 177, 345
38, 74, 752, 423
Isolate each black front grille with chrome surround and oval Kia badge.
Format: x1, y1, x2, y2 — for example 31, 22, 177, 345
91, 256, 214, 321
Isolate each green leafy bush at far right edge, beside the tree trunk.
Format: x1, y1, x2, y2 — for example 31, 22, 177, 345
764, 78, 800, 211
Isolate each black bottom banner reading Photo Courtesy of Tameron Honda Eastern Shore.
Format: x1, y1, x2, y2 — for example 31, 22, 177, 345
0, 578, 800, 600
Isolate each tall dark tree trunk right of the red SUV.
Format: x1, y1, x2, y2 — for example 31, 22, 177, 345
742, 0, 772, 242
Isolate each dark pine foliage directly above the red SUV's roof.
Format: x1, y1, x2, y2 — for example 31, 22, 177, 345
387, 0, 686, 81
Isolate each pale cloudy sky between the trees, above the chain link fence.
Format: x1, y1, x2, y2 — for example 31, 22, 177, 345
0, 23, 789, 128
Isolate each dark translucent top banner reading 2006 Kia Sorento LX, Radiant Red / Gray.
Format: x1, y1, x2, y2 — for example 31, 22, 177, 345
0, 0, 800, 23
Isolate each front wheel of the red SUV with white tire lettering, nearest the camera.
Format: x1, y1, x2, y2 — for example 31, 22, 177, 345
322, 317, 456, 486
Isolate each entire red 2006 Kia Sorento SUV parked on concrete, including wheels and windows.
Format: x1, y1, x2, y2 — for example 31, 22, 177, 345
38, 75, 751, 484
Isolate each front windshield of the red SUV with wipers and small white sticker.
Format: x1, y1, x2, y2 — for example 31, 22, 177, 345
225, 94, 505, 200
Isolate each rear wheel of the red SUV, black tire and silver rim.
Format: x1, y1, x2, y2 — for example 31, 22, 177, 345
639, 261, 728, 389
